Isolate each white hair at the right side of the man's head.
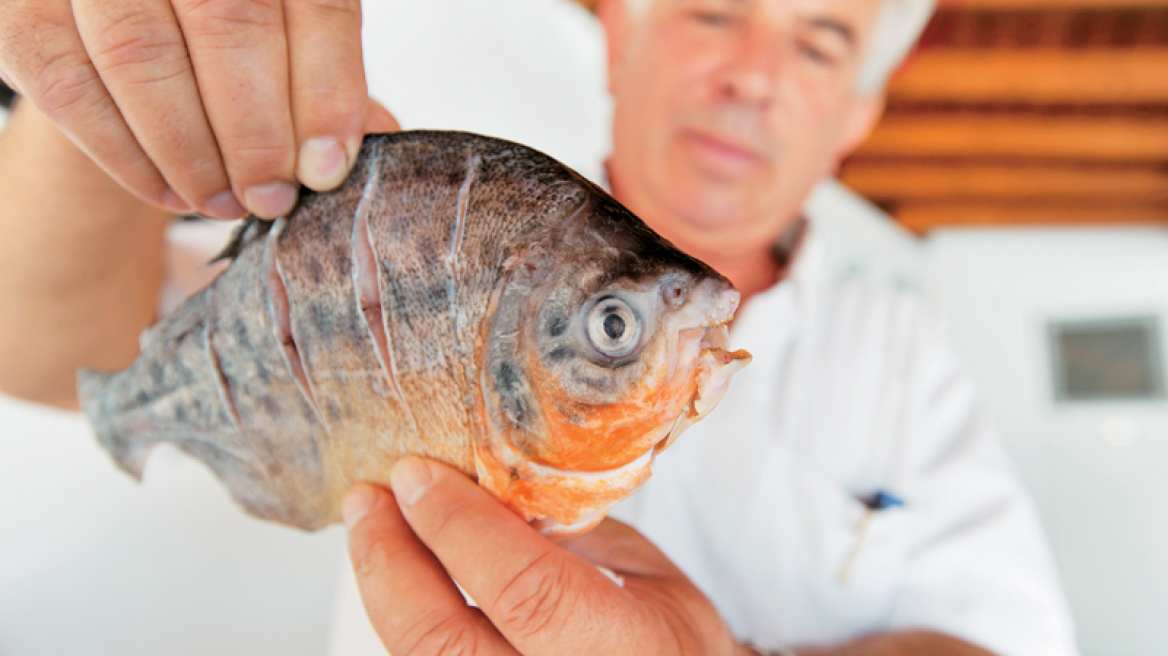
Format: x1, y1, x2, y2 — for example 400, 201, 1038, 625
624, 0, 937, 93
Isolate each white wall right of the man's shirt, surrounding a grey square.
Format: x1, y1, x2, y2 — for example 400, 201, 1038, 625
926, 229, 1168, 656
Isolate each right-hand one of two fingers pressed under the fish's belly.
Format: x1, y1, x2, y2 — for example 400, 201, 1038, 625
390, 458, 666, 655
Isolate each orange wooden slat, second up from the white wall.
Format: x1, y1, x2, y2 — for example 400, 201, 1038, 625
840, 160, 1168, 202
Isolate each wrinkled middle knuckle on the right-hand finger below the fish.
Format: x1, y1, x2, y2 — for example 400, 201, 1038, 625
495, 553, 575, 640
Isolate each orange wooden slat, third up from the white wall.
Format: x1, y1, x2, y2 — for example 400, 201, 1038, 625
857, 114, 1168, 162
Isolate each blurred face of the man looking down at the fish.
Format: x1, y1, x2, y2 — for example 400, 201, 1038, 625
600, 0, 881, 257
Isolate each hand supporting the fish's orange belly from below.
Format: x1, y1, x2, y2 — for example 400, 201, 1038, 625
343, 458, 751, 656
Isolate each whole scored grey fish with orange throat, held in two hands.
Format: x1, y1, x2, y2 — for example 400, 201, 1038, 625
78, 132, 750, 533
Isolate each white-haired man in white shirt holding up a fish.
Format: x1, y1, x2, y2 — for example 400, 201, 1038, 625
0, 0, 1073, 655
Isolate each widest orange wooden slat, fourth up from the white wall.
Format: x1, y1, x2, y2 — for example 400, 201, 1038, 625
889, 48, 1168, 104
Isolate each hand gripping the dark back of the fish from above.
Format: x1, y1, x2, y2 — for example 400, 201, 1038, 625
0, 0, 397, 218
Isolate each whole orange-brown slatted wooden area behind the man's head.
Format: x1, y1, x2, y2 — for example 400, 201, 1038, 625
841, 0, 1168, 232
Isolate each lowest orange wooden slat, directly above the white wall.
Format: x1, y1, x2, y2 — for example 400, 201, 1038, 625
892, 202, 1168, 233
